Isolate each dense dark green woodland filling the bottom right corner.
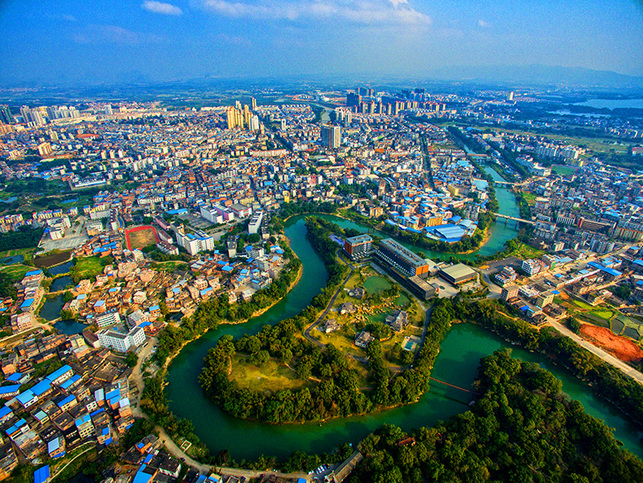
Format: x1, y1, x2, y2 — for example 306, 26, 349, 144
348, 350, 643, 483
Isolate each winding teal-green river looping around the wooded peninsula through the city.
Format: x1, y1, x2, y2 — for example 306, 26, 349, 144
166, 170, 643, 460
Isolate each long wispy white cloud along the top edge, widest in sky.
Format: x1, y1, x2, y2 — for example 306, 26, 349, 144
203, 0, 431, 25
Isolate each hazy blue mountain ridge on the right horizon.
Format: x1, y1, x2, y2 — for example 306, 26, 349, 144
427, 64, 643, 88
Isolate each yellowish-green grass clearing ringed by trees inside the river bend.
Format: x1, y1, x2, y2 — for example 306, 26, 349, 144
230, 354, 305, 391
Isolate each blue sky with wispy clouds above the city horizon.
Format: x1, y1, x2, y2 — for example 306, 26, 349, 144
0, 0, 643, 85
